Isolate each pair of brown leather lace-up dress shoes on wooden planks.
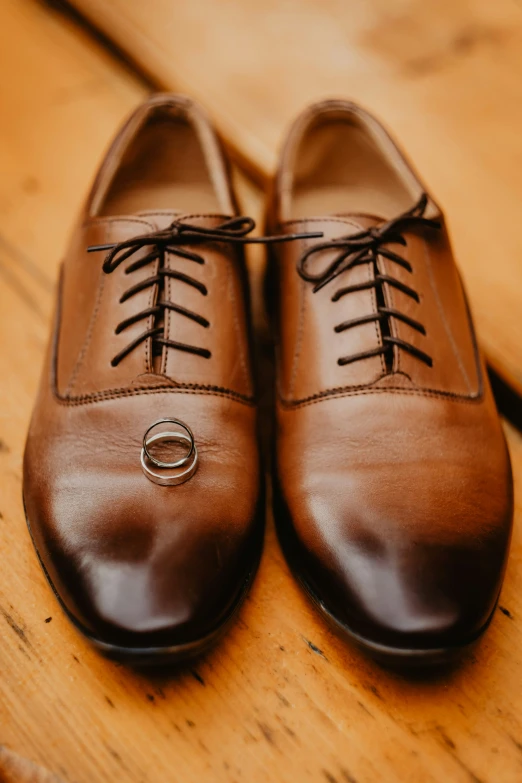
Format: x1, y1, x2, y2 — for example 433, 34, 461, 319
24, 95, 512, 662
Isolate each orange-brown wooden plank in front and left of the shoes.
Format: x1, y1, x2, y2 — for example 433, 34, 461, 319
0, 0, 522, 783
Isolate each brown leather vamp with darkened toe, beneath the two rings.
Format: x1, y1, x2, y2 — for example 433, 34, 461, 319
24, 392, 259, 631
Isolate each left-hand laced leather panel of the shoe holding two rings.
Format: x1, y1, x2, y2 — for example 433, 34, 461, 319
57, 218, 157, 397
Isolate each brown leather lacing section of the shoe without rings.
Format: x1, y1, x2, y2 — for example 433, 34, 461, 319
272, 215, 481, 403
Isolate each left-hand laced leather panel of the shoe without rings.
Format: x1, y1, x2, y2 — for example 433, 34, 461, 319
279, 217, 385, 401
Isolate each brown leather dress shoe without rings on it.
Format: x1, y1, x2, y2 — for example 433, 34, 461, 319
269, 101, 513, 663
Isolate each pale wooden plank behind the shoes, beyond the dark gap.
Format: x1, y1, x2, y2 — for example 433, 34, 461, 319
71, 0, 522, 393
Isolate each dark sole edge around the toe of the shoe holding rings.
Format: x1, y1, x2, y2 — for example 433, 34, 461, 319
24, 502, 264, 667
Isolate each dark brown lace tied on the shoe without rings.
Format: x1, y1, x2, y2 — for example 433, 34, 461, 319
297, 193, 440, 372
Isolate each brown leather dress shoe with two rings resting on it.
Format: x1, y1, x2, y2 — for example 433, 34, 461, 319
24, 96, 264, 662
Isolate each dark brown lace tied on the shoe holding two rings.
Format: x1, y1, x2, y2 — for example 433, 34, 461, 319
87, 216, 323, 367
